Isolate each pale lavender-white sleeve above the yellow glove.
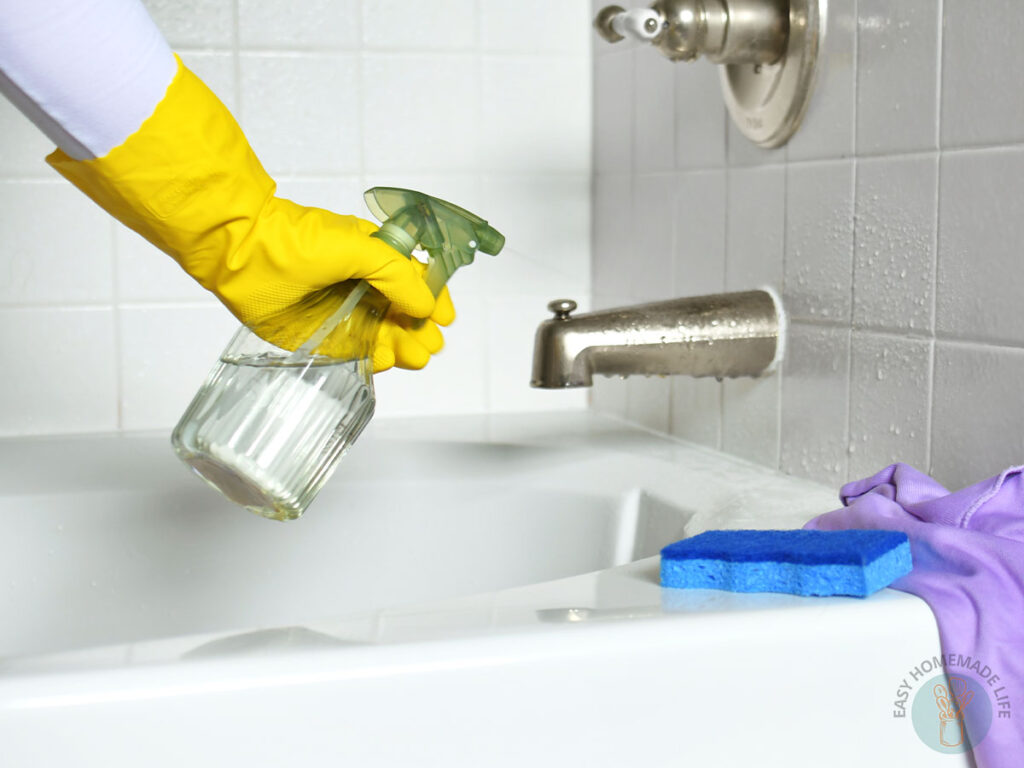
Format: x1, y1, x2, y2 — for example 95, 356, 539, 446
0, 0, 177, 160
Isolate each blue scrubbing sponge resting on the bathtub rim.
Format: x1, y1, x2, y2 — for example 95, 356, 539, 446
662, 530, 913, 597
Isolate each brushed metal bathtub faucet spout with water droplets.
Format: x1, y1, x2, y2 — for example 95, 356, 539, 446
530, 291, 783, 389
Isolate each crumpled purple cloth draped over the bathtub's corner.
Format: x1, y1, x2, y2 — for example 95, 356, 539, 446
805, 464, 1024, 768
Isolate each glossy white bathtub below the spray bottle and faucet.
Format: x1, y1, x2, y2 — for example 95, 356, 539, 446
0, 413, 950, 768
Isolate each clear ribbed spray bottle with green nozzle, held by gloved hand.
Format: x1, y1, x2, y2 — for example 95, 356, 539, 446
171, 187, 505, 520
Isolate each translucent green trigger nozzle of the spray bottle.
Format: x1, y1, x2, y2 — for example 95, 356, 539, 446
362, 186, 505, 296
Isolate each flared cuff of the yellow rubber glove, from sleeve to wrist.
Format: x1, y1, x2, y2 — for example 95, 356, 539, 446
46, 56, 275, 293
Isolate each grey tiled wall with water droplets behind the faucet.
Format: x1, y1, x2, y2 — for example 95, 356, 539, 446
592, 0, 1024, 487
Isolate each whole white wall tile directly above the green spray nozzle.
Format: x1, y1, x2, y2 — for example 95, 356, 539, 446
362, 54, 481, 173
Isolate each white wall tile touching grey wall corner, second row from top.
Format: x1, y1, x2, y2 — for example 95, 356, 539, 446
480, 55, 591, 173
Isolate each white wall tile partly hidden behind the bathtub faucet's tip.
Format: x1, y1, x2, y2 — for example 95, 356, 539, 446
486, 295, 587, 413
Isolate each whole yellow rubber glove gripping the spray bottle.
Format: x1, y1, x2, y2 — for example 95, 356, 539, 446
46, 54, 455, 371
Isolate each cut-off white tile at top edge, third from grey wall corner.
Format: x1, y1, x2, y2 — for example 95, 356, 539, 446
238, 0, 359, 50
